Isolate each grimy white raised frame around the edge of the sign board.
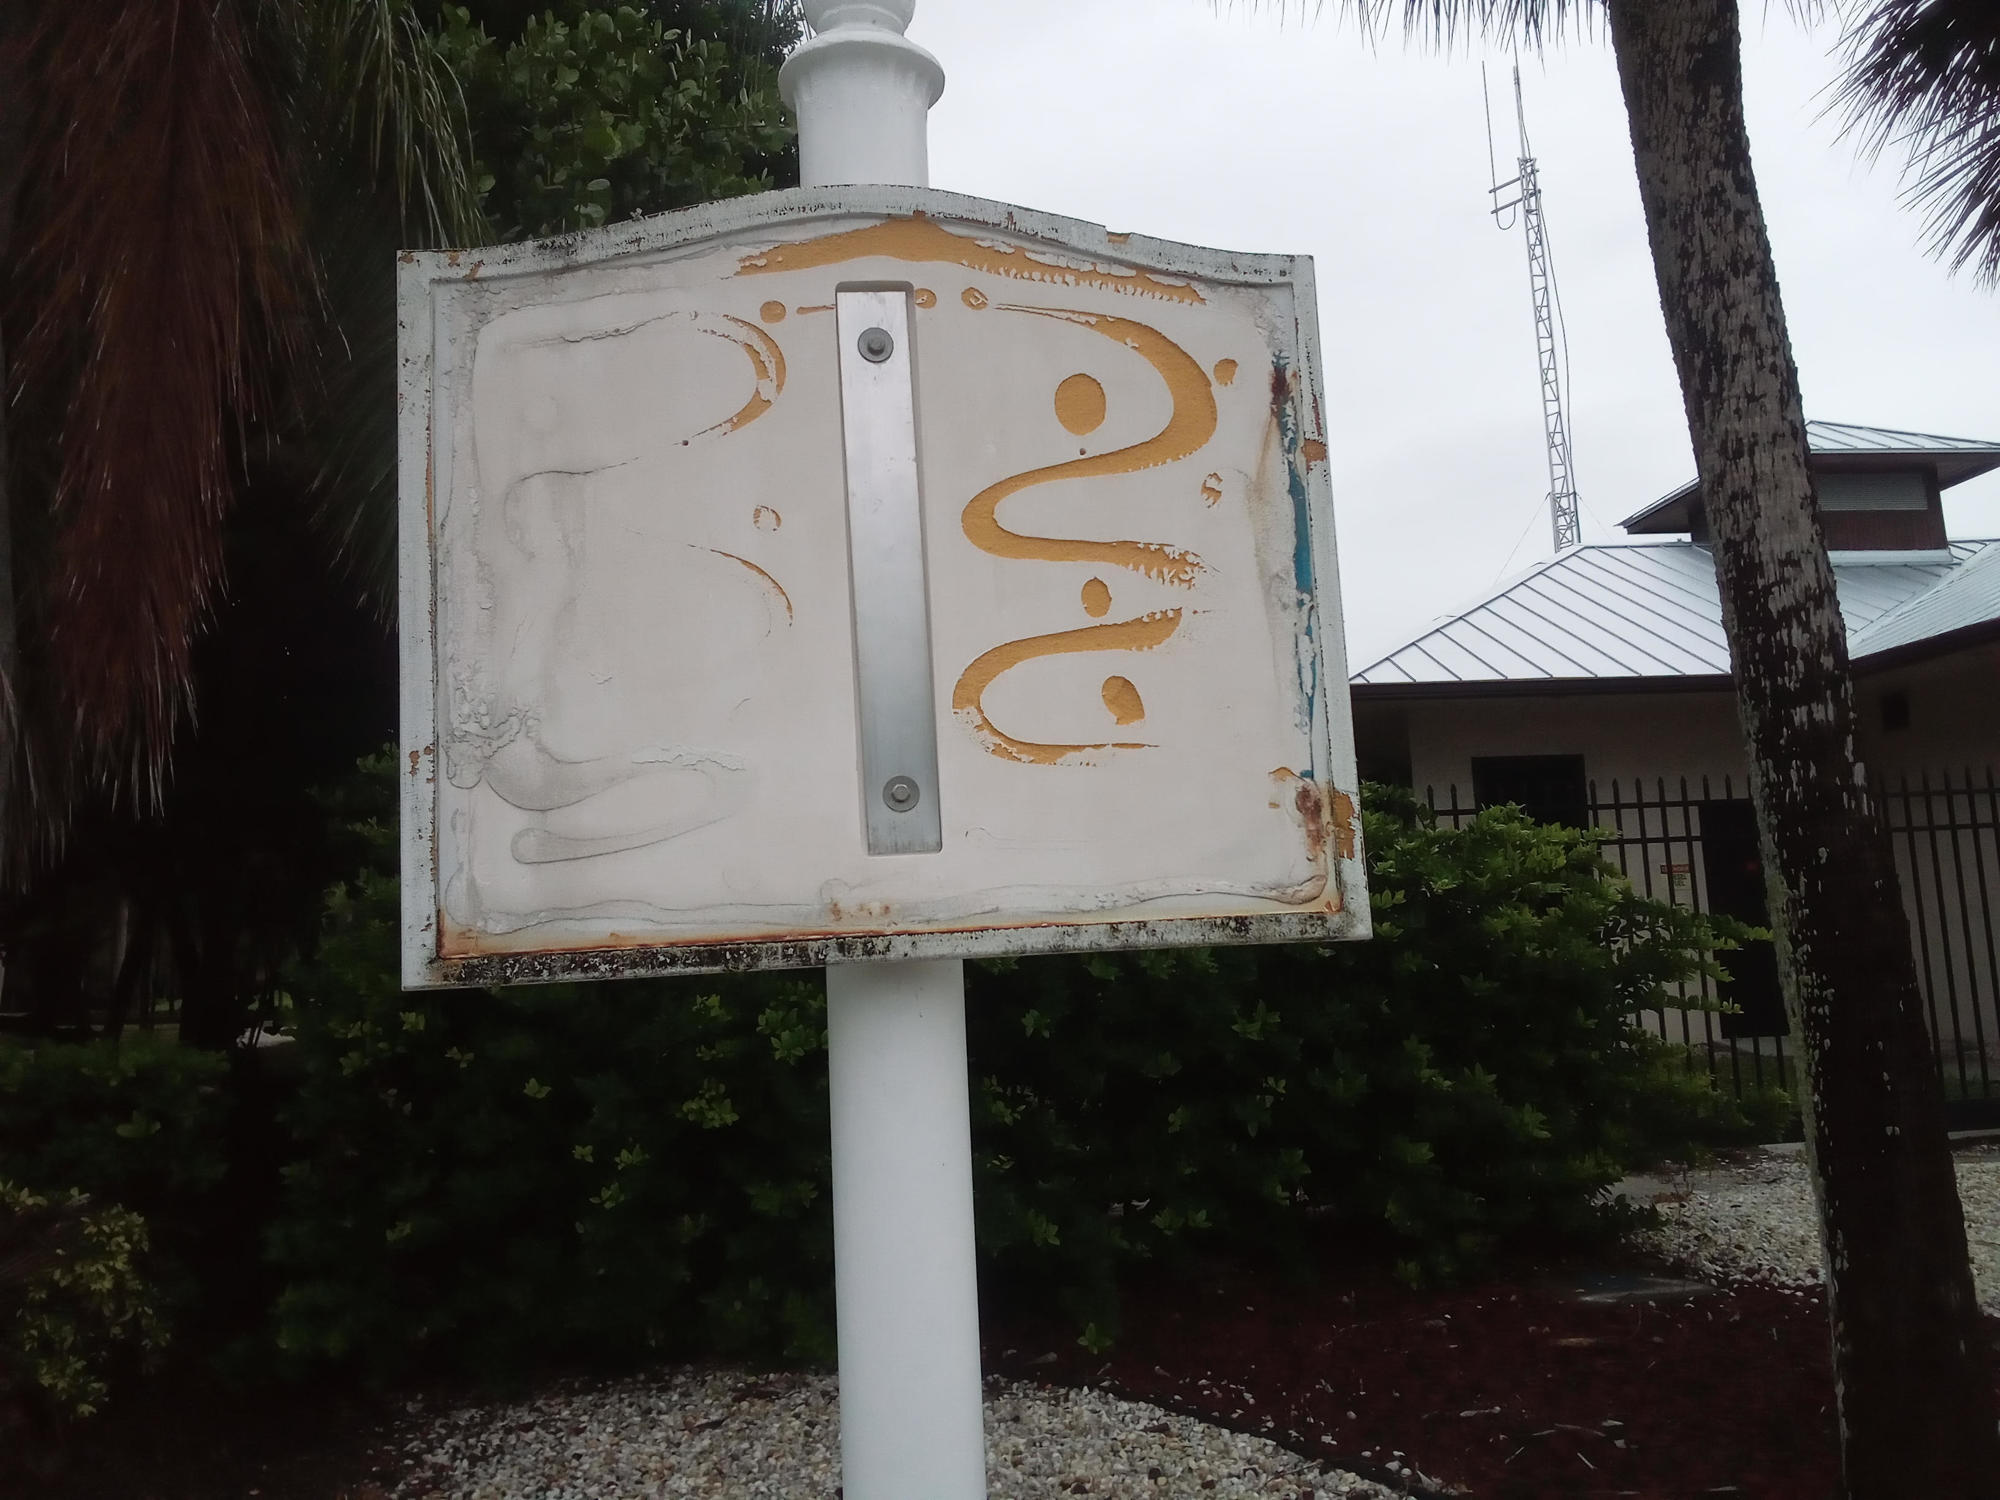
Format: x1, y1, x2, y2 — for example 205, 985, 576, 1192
398, 186, 1370, 988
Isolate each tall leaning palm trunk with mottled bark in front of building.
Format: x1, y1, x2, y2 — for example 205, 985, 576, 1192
1608, 0, 2000, 1500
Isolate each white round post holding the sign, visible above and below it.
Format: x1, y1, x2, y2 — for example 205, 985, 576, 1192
778, 11, 986, 1500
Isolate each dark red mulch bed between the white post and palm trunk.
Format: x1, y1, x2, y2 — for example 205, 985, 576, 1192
988, 1270, 2000, 1500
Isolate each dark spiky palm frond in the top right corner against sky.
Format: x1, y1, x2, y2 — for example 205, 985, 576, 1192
1834, 0, 2000, 284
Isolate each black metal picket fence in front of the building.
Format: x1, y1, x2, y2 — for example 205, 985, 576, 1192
1424, 766, 2000, 1126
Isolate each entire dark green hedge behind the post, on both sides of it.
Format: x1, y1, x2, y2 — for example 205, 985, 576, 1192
258, 768, 1776, 1370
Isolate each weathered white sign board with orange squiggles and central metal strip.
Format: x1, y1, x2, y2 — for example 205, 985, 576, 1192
400, 188, 1368, 986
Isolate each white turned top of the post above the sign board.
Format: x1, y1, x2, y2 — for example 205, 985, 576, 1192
778, 0, 944, 188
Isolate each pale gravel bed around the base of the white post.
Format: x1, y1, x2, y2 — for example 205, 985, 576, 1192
394, 1368, 1396, 1500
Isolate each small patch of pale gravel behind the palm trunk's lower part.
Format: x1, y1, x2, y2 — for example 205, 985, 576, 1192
1634, 1146, 2000, 1314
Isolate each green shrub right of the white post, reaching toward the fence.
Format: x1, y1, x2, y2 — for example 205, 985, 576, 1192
970, 788, 1768, 1316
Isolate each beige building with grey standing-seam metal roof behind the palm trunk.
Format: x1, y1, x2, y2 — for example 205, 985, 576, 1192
1350, 422, 2000, 1118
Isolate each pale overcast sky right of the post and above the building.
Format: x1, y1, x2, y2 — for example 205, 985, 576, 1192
910, 0, 2000, 668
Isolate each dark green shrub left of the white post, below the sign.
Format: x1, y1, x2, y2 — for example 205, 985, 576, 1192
268, 764, 832, 1372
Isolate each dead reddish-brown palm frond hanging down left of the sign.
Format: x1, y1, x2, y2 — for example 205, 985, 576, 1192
10, 0, 310, 792
